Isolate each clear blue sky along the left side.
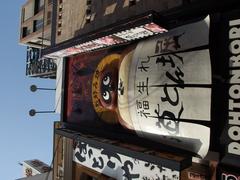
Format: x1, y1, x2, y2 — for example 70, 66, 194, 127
0, 0, 59, 180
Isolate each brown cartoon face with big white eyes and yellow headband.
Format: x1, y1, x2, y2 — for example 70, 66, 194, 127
92, 54, 121, 124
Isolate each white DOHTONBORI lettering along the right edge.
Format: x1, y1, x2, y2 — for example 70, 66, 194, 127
226, 19, 240, 156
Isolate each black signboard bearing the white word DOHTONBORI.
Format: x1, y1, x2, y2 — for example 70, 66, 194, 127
210, 9, 240, 166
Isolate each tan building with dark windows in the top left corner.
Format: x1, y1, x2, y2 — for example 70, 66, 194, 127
19, 0, 52, 48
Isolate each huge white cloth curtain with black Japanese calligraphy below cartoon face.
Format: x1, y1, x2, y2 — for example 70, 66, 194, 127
118, 17, 212, 157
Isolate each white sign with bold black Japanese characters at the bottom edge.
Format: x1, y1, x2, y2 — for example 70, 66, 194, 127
73, 140, 180, 180
